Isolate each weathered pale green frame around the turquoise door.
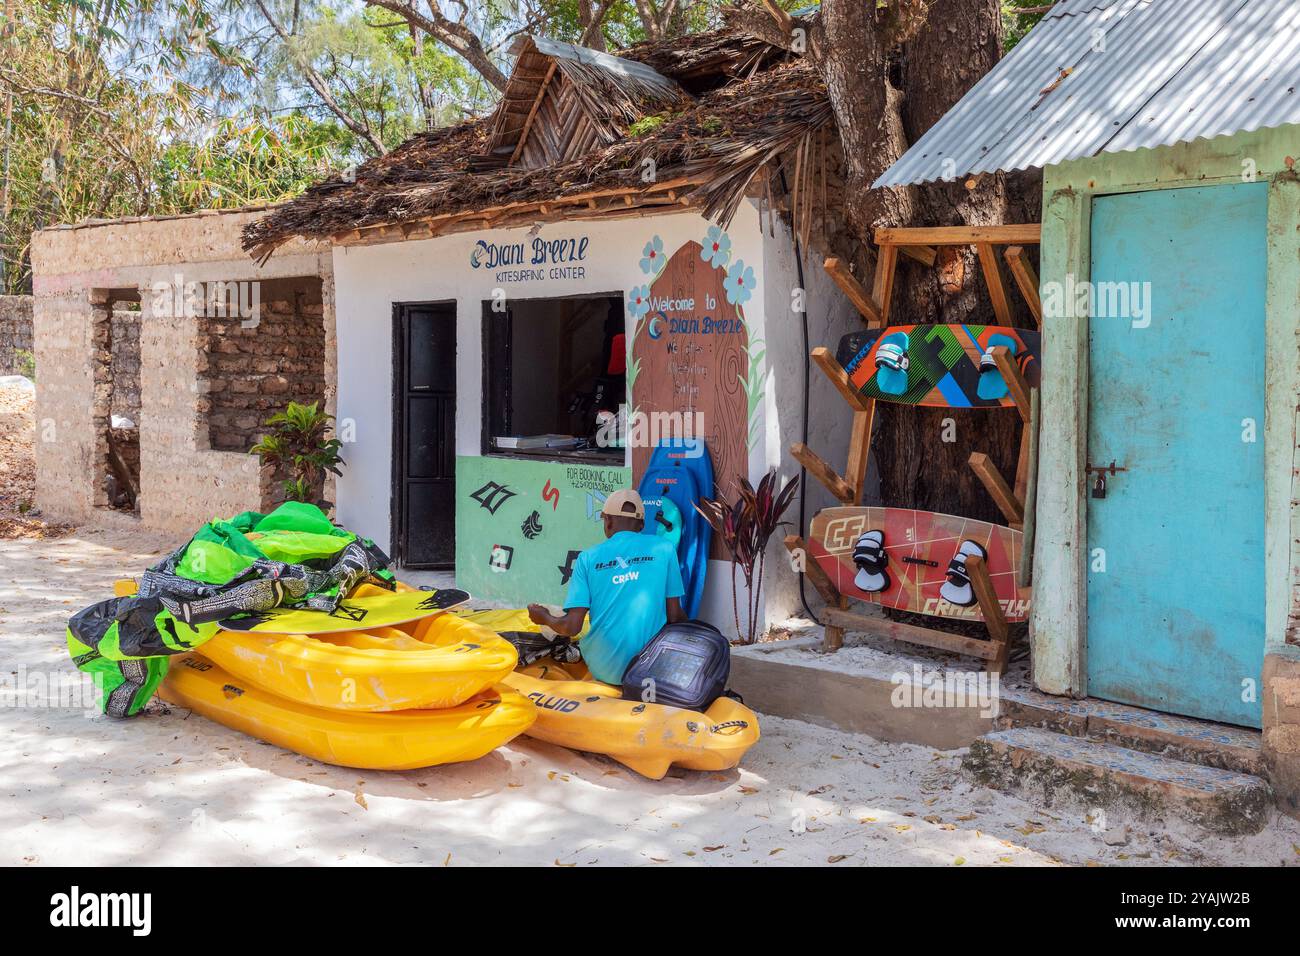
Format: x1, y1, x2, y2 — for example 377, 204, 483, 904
1030, 127, 1300, 697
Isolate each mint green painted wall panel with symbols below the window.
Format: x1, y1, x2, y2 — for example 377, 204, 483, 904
456, 455, 632, 606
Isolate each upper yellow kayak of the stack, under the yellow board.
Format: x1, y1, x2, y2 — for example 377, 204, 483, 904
203, 614, 517, 711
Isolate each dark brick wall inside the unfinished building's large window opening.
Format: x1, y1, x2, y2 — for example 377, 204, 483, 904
199, 278, 325, 451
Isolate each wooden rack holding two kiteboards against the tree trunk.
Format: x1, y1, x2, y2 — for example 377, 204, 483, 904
785, 222, 1043, 674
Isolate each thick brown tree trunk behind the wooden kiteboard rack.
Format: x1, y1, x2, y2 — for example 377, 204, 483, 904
815, 0, 1037, 522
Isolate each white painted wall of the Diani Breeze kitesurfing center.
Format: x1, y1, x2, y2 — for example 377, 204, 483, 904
334, 202, 852, 632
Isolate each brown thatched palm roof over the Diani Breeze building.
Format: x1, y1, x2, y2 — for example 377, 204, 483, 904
244, 15, 832, 258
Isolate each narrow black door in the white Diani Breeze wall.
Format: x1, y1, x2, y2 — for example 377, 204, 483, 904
394, 304, 456, 568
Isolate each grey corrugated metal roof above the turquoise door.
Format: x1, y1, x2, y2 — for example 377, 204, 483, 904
875, 0, 1300, 186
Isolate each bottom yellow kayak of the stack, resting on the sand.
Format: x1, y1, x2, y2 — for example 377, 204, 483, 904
159, 652, 537, 770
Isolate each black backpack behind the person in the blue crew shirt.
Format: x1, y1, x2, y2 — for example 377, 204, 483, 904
623, 620, 731, 710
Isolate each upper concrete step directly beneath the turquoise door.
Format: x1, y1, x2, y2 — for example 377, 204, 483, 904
996, 691, 1264, 775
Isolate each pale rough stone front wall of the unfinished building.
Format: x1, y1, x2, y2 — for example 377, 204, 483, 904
33, 212, 335, 535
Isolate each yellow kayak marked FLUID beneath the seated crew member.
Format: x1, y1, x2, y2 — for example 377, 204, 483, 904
502, 663, 759, 780
